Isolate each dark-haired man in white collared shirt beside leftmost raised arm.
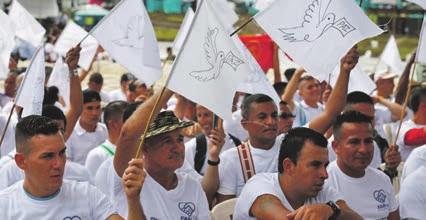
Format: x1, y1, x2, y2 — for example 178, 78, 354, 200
67, 90, 108, 165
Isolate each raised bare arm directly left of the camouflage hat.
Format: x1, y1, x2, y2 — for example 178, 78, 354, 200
114, 89, 173, 176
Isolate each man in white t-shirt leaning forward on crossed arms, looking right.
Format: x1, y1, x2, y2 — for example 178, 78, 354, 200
233, 128, 361, 220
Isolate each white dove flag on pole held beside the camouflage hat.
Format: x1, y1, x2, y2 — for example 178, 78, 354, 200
166, 0, 251, 120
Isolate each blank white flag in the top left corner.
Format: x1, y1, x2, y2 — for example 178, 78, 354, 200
9, 0, 46, 47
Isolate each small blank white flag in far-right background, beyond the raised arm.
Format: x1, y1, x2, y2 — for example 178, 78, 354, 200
380, 35, 404, 75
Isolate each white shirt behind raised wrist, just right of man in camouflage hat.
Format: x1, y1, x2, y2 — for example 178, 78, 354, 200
185, 135, 235, 174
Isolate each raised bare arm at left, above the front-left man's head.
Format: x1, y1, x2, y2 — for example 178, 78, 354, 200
64, 45, 83, 141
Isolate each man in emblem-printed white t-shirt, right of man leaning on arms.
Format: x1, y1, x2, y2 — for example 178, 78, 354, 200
327, 111, 399, 220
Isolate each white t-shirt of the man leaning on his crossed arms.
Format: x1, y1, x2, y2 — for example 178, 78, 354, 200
233, 173, 343, 220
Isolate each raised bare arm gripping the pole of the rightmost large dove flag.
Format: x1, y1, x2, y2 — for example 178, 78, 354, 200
309, 46, 359, 134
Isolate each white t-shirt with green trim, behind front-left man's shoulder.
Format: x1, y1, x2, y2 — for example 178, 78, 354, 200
84, 139, 116, 177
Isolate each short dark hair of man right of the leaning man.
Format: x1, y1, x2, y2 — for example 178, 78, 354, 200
333, 111, 373, 140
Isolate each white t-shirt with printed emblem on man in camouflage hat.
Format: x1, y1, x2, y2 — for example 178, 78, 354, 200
114, 168, 210, 219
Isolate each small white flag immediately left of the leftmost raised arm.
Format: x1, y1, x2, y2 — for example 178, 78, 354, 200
47, 57, 70, 107
